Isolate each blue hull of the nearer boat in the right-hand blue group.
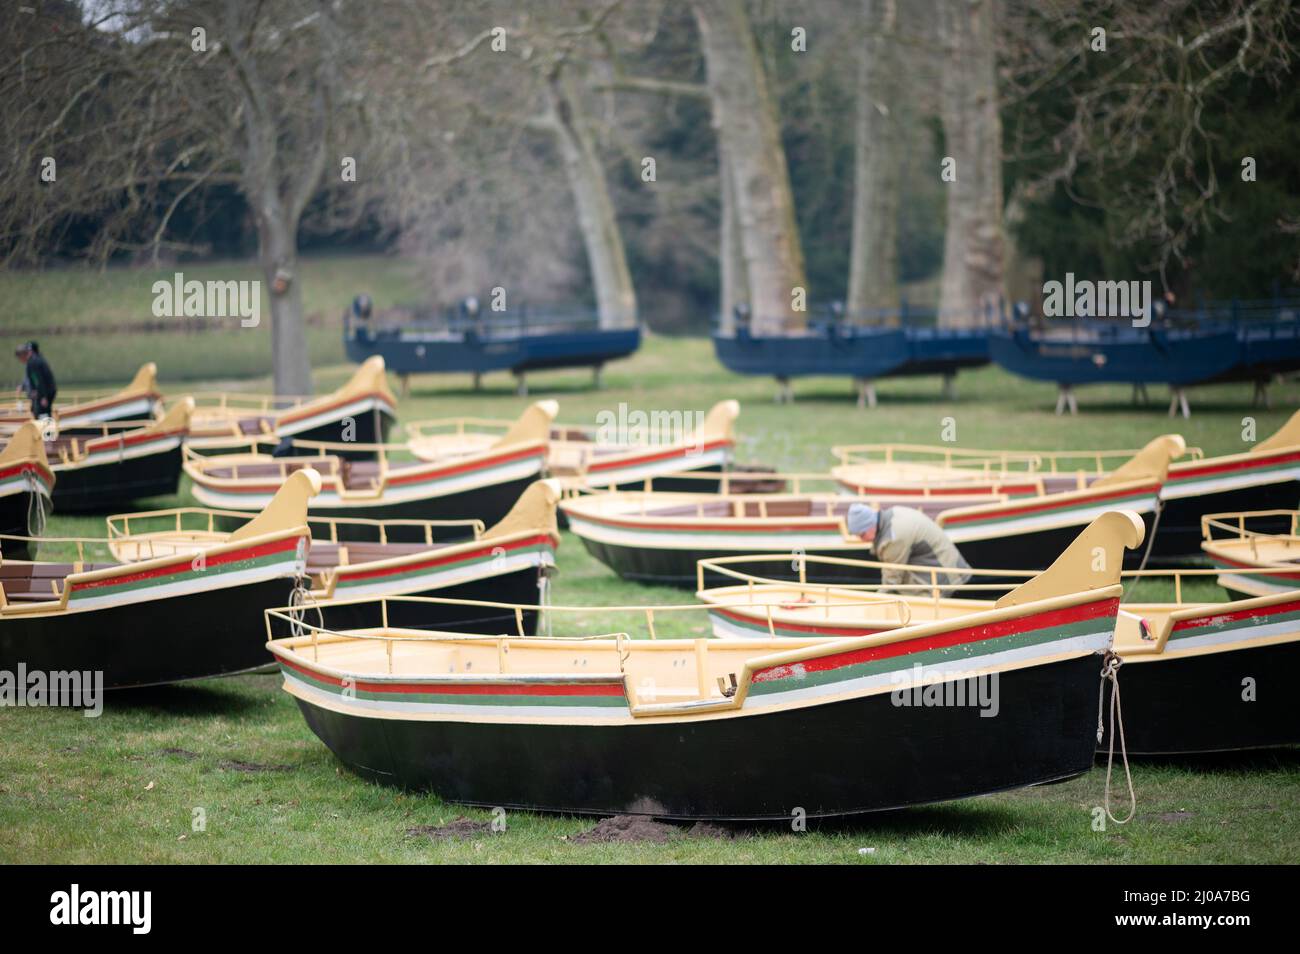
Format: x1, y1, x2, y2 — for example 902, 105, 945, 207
989, 328, 1240, 387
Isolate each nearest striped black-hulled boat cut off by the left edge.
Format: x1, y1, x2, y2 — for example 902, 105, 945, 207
0, 472, 320, 689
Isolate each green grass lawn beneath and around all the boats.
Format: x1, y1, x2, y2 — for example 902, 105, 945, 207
0, 259, 1300, 864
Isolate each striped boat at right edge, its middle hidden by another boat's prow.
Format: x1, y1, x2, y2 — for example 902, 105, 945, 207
832, 411, 1300, 559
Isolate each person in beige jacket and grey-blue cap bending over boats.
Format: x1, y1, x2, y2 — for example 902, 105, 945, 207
846, 503, 971, 597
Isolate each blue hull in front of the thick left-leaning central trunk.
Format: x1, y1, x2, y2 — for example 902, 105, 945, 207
714, 328, 909, 378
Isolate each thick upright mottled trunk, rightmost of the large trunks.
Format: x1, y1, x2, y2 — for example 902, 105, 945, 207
939, 0, 1002, 326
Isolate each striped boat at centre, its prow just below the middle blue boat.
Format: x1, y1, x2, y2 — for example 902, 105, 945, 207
416, 400, 740, 490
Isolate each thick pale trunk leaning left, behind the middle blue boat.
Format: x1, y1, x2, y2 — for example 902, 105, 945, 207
693, 0, 807, 333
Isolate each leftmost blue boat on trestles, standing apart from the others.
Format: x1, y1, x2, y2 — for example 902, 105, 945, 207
345, 328, 641, 374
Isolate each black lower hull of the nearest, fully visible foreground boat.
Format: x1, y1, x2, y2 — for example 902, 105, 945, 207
298, 655, 1101, 823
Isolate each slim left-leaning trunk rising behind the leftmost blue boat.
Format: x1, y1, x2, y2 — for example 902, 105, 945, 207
547, 70, 637, 328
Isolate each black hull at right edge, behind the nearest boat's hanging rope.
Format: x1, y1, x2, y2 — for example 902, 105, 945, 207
1101, 642, 1300, 755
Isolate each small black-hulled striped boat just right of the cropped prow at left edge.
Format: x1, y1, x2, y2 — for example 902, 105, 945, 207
35, 398, 194, 513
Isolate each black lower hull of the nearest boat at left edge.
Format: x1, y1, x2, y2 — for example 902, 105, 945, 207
0, 577, 294, 689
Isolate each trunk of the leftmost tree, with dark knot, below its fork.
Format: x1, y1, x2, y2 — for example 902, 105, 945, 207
256, 198, 312, 394
